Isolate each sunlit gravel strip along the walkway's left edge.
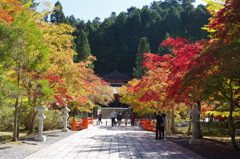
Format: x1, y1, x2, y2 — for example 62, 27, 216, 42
0, 130, 77, 159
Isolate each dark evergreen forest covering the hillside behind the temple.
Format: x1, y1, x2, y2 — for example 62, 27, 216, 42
46, 0, 210, 77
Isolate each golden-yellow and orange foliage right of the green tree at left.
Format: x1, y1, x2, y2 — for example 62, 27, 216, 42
39, 22, 104, 111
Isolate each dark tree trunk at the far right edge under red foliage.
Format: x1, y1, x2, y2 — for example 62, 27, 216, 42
228, 101, 240, 151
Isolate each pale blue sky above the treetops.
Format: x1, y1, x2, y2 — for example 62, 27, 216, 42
39, 0, 204, 21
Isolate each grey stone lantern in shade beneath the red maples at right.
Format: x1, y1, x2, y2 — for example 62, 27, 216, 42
189, 104, 200, 144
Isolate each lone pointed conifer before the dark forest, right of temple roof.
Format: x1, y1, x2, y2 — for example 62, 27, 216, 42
133, 37, 151, 79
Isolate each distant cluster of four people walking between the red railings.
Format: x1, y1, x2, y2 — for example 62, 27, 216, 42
110, 110, 135, 126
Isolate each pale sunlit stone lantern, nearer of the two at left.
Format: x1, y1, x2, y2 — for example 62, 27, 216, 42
34, 103, 47, 141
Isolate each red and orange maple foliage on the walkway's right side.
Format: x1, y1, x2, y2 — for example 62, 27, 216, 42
118, 0, 240, 149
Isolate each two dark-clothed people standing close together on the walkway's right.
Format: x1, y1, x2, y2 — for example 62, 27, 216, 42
155, 111, 166, 139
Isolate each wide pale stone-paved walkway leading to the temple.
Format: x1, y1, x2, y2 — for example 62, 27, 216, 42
25, 120, 203, 159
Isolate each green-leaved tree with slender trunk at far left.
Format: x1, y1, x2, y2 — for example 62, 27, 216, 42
1, 10, 49, 141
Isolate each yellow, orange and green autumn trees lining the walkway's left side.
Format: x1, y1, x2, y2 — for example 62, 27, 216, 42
0, 0, 112, 141
